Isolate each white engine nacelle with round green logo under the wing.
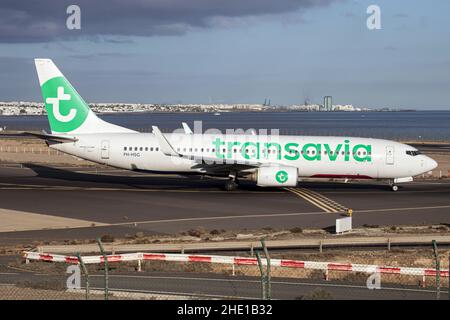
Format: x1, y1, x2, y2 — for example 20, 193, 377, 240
253, 166, 298, 187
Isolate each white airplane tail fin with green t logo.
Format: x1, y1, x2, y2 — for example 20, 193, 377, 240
34, 59, 135, 134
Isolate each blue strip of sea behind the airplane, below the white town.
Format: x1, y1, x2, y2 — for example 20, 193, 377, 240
0, 110, 450, 141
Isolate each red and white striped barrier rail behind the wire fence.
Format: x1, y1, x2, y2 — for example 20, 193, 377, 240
23, 252, 449, 277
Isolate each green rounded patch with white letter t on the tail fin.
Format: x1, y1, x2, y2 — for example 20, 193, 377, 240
41, 77, 89, 132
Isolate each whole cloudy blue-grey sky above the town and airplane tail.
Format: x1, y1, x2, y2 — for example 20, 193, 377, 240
0, 0, 450, 110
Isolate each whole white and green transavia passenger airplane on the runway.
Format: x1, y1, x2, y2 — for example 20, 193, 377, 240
33, 59, 437, 191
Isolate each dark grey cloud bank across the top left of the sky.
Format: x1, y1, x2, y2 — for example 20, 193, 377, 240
0, 0, 339, 43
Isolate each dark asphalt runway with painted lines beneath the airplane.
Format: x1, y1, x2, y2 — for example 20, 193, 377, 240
0, 164, 450, 244
